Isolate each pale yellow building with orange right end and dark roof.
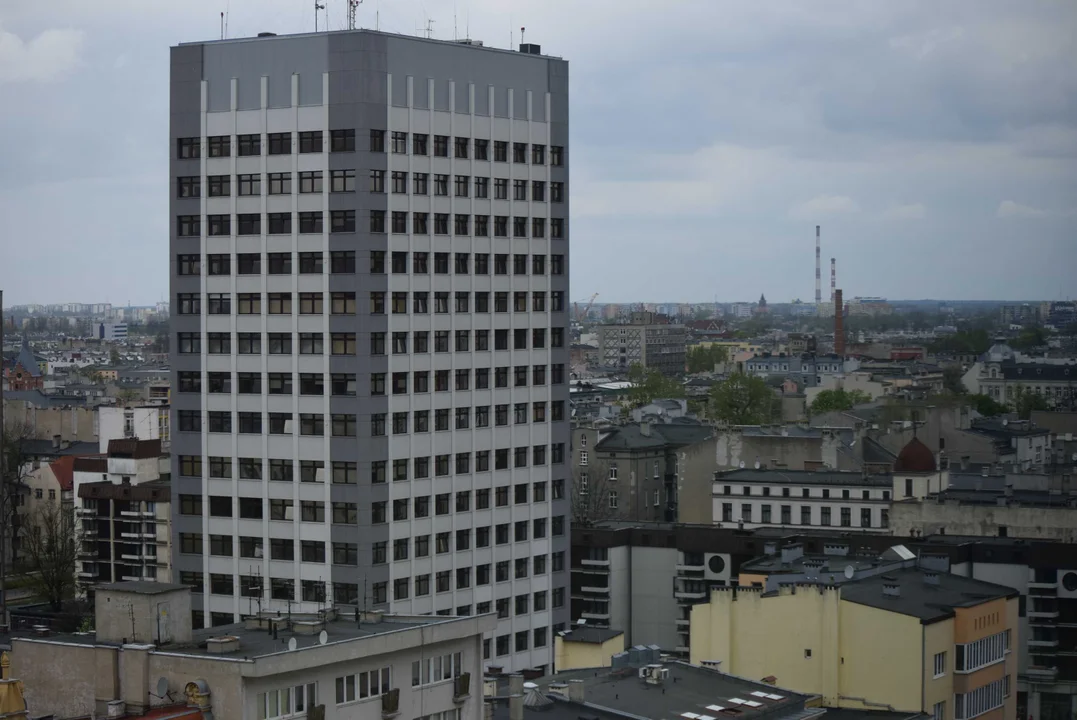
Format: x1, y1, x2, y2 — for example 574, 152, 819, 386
690, 566, 1018, 720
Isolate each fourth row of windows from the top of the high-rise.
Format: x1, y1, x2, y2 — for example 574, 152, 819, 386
176, 250, 564, 276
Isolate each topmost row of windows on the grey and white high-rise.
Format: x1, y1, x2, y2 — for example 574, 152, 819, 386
176, 129, 564, 167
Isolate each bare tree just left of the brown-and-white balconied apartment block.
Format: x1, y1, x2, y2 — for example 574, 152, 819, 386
22, 500, 80, 610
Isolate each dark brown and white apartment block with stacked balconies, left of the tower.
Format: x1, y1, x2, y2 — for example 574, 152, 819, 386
72, 440, 172, 594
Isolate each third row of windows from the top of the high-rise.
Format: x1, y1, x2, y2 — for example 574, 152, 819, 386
176, 210, 564, 239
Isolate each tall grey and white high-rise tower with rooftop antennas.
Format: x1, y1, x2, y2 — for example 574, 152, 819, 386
169, 30, 571, 668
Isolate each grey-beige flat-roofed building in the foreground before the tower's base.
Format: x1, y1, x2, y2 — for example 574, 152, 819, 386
12, 582, 495, 720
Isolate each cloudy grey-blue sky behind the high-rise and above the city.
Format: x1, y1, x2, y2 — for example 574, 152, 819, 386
0, 0, 1077, 305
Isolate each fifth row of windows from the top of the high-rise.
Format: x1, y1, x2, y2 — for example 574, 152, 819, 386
174, 290, 564, 316
